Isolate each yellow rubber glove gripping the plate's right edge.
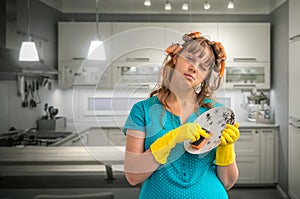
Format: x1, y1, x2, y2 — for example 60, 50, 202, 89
216, 123, 240, 166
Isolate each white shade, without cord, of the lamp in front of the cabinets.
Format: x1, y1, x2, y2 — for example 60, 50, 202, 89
87, 40, 106, 60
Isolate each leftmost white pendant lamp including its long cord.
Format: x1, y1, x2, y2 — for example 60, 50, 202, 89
19, 0, 40, 61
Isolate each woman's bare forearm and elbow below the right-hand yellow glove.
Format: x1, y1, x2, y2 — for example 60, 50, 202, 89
217, 161, 239, 190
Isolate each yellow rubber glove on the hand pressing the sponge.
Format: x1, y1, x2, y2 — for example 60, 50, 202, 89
150, 123, 210, 164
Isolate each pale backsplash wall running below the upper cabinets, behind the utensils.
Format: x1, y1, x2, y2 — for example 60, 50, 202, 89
0, 77, 269, 133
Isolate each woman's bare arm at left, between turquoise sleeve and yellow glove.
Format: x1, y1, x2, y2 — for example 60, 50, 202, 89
124, 129, 159, 186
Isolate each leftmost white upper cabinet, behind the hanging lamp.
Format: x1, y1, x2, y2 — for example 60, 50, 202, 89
58, 22, 111, 88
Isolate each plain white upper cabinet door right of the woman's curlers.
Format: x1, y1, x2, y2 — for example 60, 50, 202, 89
219, 23, 270, 62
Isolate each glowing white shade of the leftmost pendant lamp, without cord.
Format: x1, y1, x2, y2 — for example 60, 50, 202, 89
19, 41, 40, 61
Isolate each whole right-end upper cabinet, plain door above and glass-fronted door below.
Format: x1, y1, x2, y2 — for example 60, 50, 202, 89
218, 23, 271, 89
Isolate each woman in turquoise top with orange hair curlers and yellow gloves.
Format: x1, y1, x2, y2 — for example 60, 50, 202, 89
123, 32, 239, 199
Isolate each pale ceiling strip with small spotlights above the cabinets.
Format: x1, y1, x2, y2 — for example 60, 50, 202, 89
40, 0, 287, 14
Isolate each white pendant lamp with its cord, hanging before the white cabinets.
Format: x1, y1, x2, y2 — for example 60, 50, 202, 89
87, 0, 106, 60
